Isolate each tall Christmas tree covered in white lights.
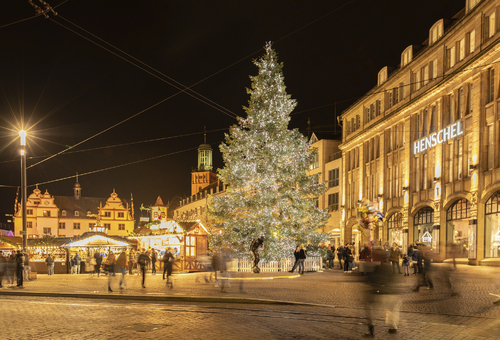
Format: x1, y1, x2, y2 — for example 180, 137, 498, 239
209, 43, 328, 260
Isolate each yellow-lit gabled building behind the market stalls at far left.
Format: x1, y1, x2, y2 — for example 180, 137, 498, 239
14, 182, 135, 238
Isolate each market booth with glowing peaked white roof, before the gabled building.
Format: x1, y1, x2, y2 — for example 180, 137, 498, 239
62, 232, 137, 273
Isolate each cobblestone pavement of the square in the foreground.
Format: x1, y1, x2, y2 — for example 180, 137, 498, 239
0, 264, 500, 339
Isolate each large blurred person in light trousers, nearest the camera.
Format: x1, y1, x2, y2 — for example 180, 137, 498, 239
364, 254, 401, 338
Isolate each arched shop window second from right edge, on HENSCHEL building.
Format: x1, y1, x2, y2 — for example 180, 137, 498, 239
446, 198, 475, 258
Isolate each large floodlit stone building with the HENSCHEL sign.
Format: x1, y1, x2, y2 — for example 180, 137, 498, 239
340, 0, 500, 264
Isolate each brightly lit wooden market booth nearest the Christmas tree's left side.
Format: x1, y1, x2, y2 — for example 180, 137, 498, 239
129, 220, 209, 271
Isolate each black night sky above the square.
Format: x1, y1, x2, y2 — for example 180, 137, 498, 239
0, 0, 465, 222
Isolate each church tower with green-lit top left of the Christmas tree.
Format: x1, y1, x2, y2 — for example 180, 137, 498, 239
191, 128, 217, 195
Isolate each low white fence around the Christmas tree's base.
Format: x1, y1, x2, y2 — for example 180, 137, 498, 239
228, 256, 323, 273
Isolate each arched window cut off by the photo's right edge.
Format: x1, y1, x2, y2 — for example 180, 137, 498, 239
484, 191, 500, 257
